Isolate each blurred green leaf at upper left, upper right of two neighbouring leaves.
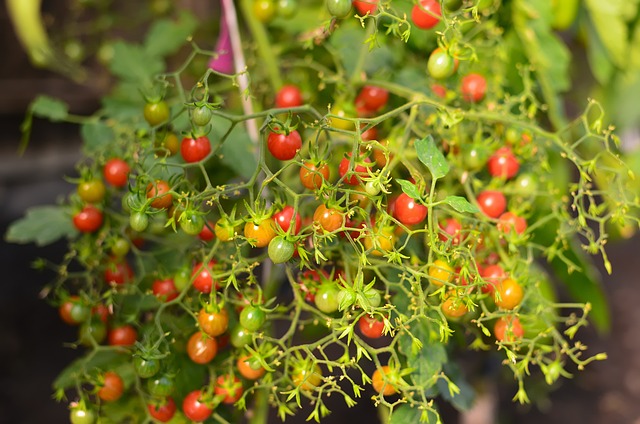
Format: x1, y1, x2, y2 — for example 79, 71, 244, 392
144, 11, 198, 57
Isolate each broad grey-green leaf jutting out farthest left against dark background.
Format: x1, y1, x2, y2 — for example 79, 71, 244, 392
5, 205, 78, 246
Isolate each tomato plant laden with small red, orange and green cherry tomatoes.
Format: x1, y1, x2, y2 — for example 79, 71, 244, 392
7, 0, 640, 423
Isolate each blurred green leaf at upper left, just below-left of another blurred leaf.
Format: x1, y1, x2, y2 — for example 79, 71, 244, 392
109, 42, 165, 87
